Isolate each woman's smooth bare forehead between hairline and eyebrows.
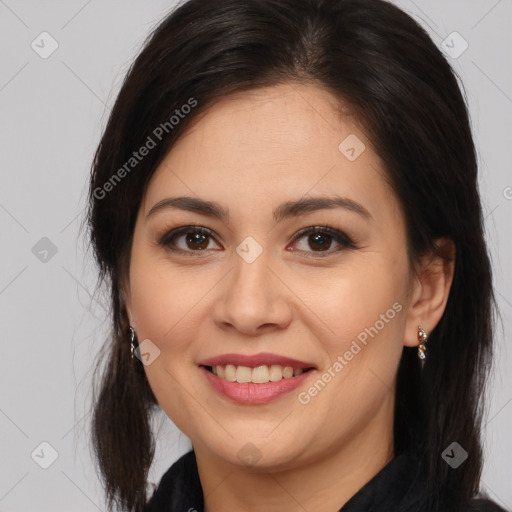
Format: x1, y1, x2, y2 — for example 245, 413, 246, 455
145, 84, 397, 226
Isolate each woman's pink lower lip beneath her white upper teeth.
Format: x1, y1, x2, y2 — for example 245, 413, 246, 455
199, 366, 314, 404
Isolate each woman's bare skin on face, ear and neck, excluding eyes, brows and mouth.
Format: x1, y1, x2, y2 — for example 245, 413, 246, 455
125, 83, 453, 512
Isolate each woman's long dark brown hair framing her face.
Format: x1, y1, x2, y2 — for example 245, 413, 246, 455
87, 0, 494, 512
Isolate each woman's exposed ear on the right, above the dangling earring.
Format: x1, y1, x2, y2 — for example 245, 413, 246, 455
404, 238, 455, 347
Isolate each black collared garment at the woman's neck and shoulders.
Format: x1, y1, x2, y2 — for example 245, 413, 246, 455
147, 451, 506, 512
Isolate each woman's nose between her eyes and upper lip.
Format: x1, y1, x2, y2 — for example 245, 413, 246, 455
214, 251, 292, 336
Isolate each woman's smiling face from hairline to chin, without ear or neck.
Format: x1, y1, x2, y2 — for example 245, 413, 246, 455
127, 84, 418, 468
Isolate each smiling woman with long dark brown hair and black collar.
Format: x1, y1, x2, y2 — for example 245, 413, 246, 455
88, 0, 508, 512
